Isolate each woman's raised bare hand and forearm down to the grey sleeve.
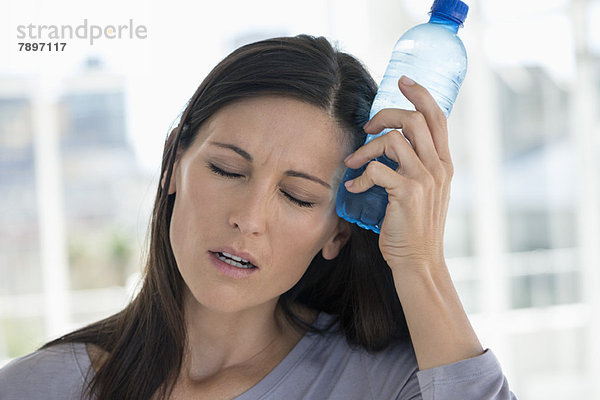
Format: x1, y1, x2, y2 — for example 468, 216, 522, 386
345, 78, 483, 370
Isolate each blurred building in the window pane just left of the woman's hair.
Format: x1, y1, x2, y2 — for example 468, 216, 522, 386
58, 59, 151, 289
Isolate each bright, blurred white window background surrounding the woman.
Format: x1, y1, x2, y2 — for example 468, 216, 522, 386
0, 0, 600, 400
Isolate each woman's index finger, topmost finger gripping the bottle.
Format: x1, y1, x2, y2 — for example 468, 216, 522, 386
398, 76, 451, 163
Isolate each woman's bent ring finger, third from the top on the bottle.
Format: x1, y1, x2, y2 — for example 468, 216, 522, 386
345, 130, 426, 177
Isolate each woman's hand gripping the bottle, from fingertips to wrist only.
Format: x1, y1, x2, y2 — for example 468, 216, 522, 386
345, 77, 453, 272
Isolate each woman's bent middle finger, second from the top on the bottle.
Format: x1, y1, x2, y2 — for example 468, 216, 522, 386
364, 108, 440, 170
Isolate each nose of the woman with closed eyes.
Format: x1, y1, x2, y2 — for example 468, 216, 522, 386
228, 187, 269, 235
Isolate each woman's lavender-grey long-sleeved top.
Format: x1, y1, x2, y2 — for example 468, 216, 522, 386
0, 313, 516, 400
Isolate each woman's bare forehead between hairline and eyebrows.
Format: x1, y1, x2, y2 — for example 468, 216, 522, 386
200, 96, 347, 161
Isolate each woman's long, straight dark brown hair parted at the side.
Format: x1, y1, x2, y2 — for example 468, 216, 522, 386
43, 35, 409, 399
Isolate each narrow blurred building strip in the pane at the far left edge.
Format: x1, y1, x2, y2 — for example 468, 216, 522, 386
0, 77, 41, 294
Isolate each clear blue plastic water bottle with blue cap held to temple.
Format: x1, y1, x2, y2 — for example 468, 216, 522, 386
336, 0, 469, 233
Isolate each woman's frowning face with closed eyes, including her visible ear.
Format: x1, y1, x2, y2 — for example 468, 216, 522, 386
169, 96, 350, 312
